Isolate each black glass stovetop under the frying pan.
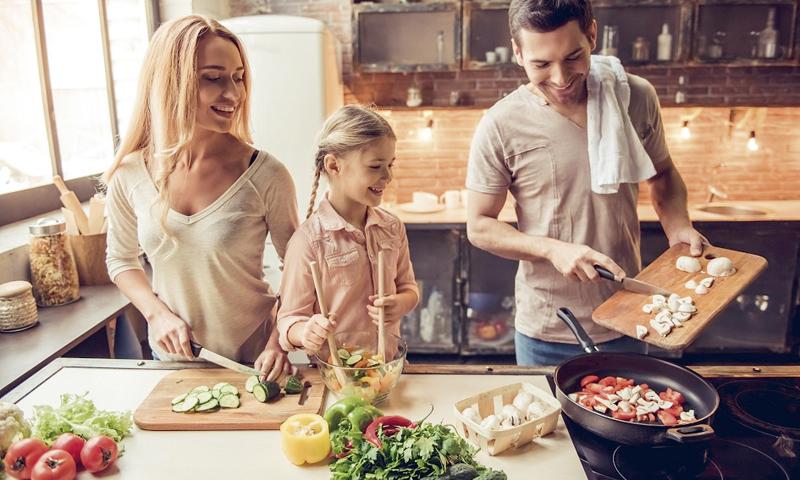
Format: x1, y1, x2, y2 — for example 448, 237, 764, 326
552, 377, 800, 480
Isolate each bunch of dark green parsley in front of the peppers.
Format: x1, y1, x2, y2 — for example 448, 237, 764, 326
330, 422, 505, 480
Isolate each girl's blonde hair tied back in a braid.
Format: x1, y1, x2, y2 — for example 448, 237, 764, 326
306, 105, 397, 218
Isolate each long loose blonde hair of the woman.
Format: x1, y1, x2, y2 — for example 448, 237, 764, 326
102, 15, 252, 236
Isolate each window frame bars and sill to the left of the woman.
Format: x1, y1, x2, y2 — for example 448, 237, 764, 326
0, 0, 161, 227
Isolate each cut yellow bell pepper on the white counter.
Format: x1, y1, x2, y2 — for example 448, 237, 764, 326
281, 413, 331, 465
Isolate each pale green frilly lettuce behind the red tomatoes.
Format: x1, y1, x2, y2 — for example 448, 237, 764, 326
32, 392, 133, 444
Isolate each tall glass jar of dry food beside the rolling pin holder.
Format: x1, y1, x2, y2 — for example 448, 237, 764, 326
28, 218, 80, 307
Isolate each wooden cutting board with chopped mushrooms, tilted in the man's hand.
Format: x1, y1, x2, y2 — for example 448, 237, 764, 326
592, 244, 767, 350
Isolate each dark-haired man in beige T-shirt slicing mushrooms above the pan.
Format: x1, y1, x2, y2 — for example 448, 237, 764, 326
467, 0, 706, 365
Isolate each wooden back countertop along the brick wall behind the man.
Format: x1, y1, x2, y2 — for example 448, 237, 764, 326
387, 200, 800, 225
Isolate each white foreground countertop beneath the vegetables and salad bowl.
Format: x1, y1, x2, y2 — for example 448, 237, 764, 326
2, 359, 800, 480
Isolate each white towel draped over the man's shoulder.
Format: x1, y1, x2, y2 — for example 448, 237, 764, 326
586, 55, 656, 193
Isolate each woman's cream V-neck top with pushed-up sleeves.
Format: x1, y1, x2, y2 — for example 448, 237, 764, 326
106, 152, 298, 362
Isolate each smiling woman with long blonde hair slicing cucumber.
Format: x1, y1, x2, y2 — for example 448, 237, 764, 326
104, 15, 298, 379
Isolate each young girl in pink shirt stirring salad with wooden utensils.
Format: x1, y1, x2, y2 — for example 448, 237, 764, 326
278, 105, 419, 353
